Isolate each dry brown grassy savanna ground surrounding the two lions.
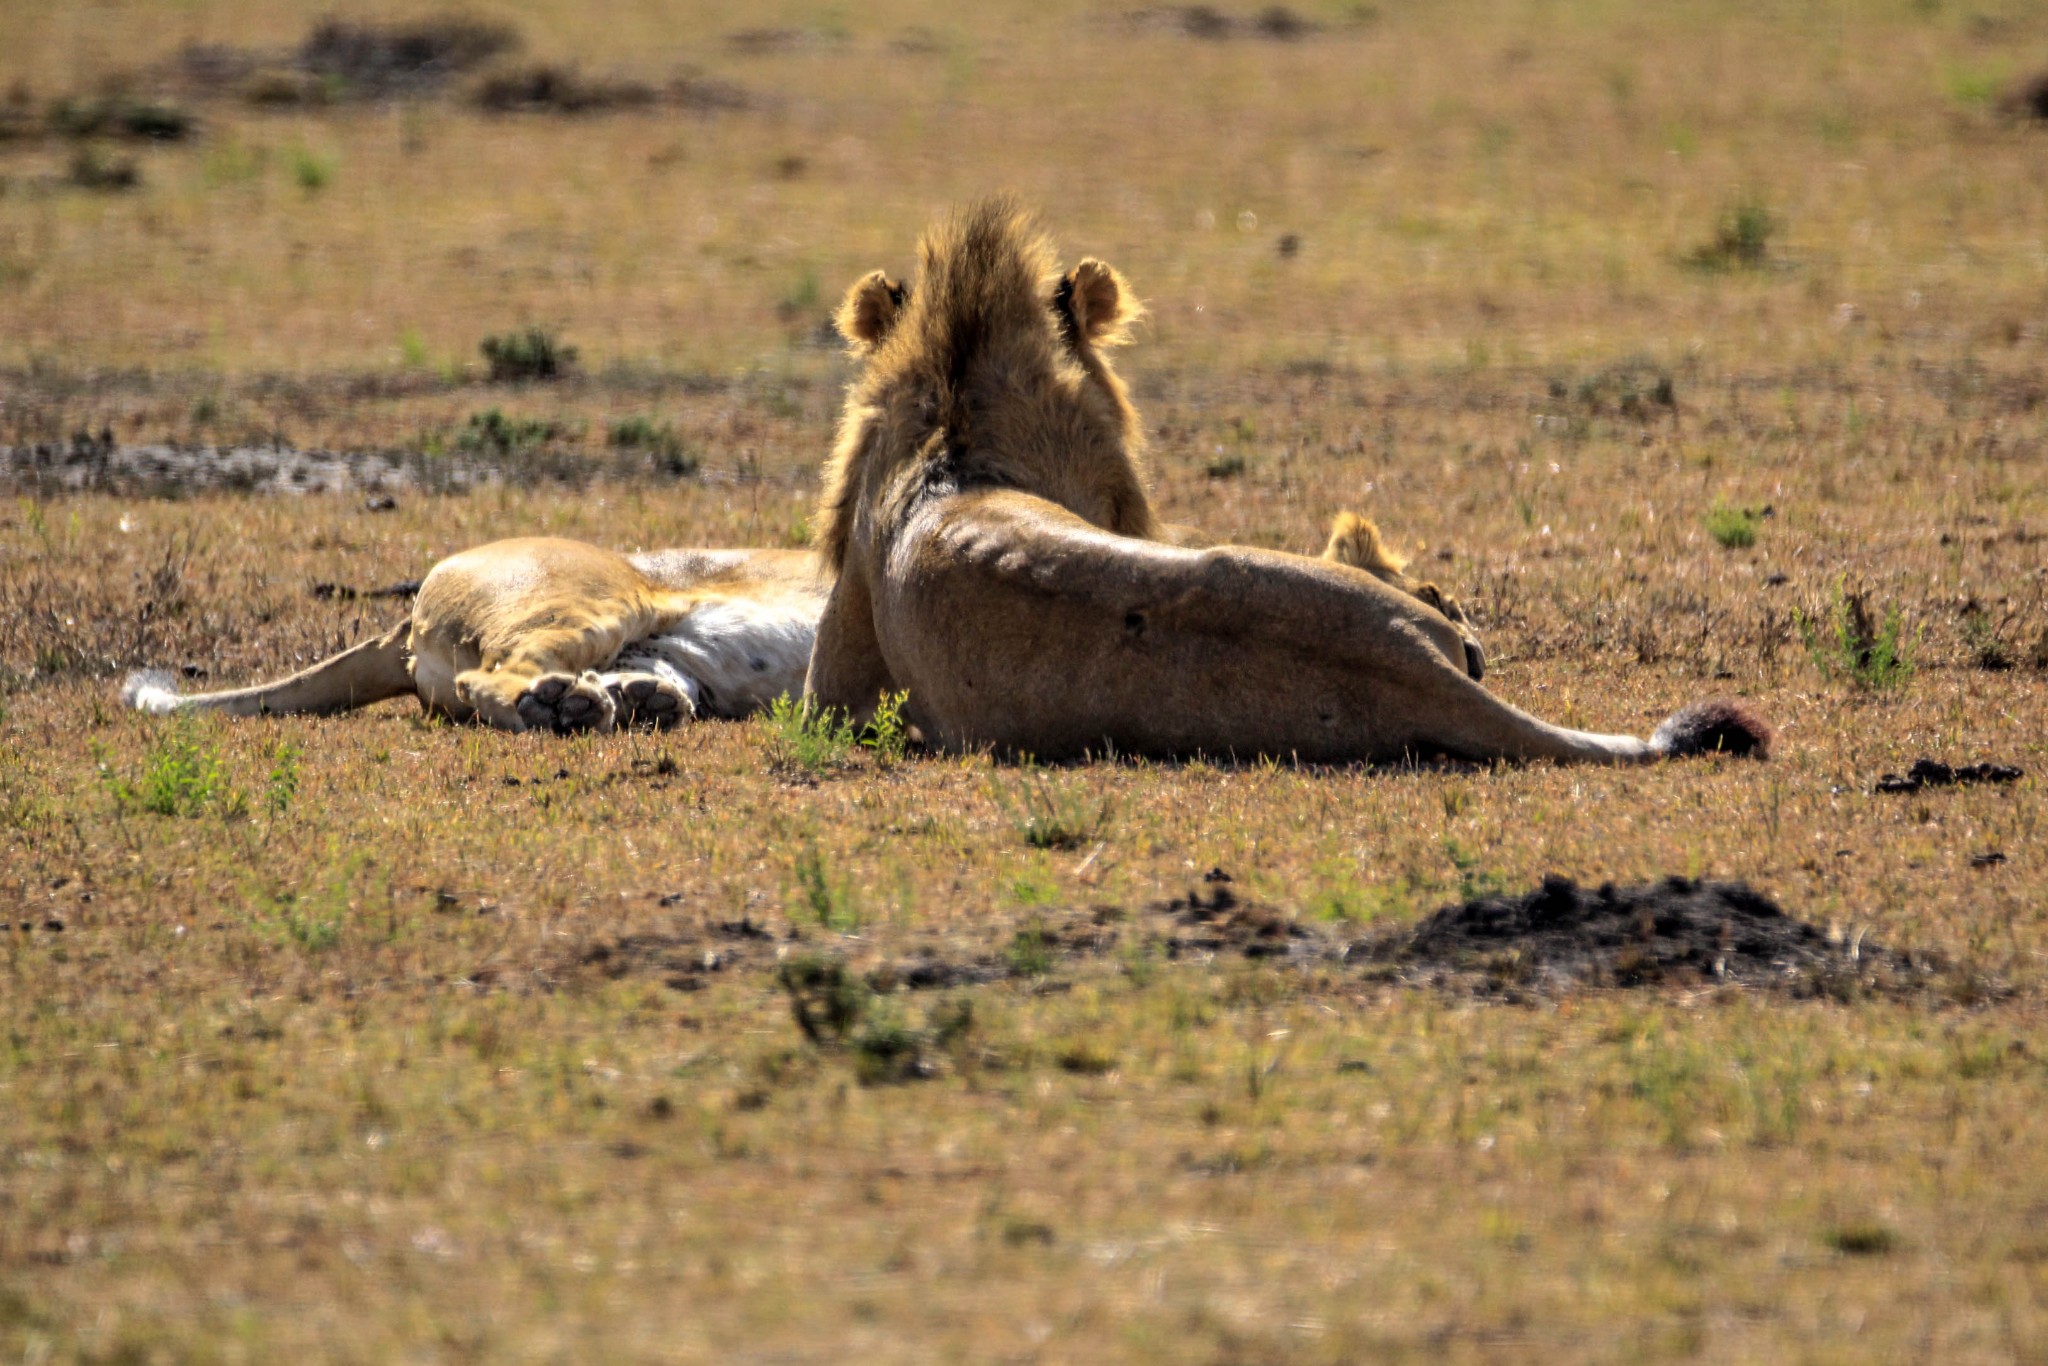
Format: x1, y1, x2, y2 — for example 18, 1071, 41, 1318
0, 0, 2048, 1362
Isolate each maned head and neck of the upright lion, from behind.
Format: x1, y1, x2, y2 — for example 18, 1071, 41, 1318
819, 199, 1157, 569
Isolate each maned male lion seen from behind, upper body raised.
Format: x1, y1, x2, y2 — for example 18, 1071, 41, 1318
807, 199, 1769, 764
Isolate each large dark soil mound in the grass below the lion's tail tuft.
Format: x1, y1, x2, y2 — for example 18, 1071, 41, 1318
1354, 877, 1927, 995
